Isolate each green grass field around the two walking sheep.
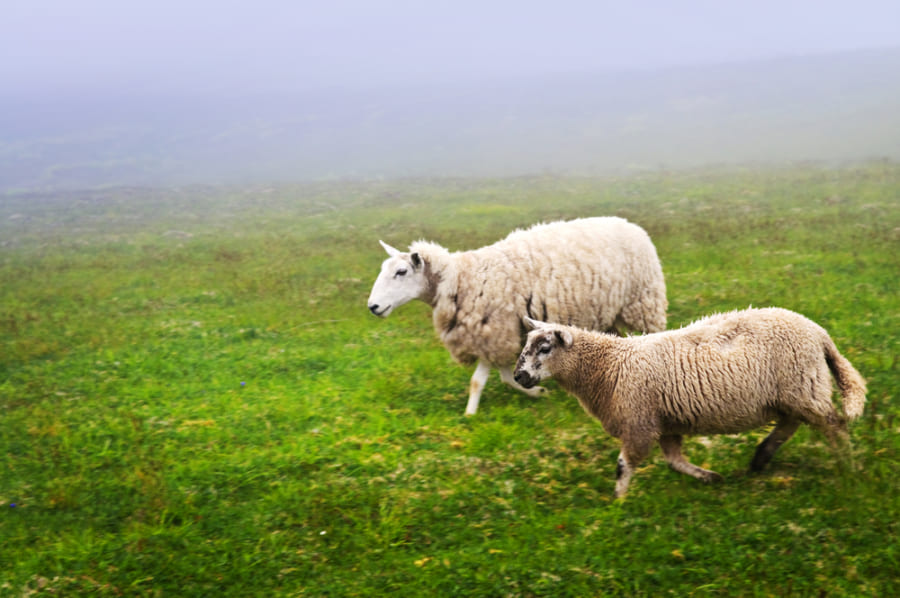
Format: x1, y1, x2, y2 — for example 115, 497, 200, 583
0, 162, 900, 597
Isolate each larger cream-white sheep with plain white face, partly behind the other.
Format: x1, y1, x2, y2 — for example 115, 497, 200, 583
368, 217, 668, 415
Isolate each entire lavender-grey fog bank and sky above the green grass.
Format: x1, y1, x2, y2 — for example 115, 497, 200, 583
0, 0, 900, 191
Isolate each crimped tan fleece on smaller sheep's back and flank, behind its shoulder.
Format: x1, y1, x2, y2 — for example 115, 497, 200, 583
629, 309, 832, 433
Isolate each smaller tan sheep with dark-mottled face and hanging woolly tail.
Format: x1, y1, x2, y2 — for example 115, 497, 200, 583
515, 308, 866, 497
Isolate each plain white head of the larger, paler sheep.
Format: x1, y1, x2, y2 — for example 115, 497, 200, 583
369, 241, 428, 318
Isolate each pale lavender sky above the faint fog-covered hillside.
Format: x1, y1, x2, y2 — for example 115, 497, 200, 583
0, 0, 900, 93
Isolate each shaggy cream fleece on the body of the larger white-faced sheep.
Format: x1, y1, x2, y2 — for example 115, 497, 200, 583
439, 218, 665, 365
